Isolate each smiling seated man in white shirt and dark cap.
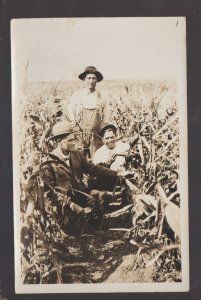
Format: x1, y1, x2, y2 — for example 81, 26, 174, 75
93, 124, 130, 171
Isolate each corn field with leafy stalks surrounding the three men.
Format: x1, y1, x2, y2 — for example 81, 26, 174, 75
17, 81, 182, 284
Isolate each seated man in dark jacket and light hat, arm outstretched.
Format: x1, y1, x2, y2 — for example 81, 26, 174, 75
40, 122, 123, 233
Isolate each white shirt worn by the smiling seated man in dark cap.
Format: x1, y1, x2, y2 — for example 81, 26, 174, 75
93, 141, 130, 171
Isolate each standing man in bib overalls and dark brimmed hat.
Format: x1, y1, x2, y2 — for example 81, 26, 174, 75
67, 66, 110, 157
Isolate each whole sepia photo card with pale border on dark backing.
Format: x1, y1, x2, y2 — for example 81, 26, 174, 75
11, 17, 189, 294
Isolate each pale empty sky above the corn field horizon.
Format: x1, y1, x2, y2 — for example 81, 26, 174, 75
11, 17, 186, 81
